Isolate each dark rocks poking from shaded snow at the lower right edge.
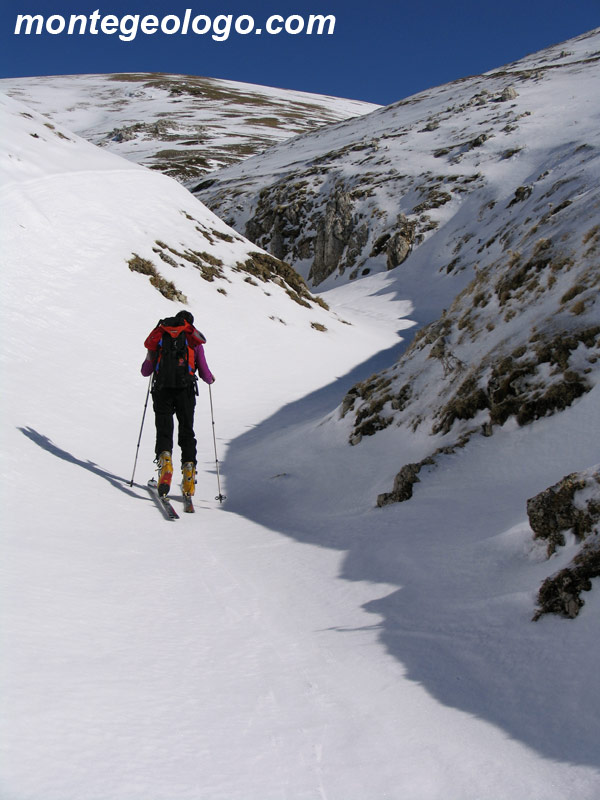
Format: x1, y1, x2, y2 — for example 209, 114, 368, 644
527, 465, 600, 620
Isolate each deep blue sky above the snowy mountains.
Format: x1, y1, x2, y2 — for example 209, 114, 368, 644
0, 0, 600, 104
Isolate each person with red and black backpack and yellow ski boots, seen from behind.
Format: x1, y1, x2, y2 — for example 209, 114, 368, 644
141, 311, 215, 496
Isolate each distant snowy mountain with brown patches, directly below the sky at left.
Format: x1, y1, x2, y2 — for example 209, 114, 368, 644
0, 73, 377, 186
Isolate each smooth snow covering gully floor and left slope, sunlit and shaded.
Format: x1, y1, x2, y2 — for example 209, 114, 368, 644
0, 48, 600, 800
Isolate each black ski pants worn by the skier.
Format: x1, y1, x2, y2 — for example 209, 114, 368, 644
152, 386, 196, 464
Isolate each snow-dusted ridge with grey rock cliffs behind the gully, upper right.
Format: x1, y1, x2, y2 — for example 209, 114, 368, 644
197, 26, 599, 288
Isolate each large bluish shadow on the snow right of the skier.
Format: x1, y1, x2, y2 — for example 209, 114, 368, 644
223, 341, 600, 767
